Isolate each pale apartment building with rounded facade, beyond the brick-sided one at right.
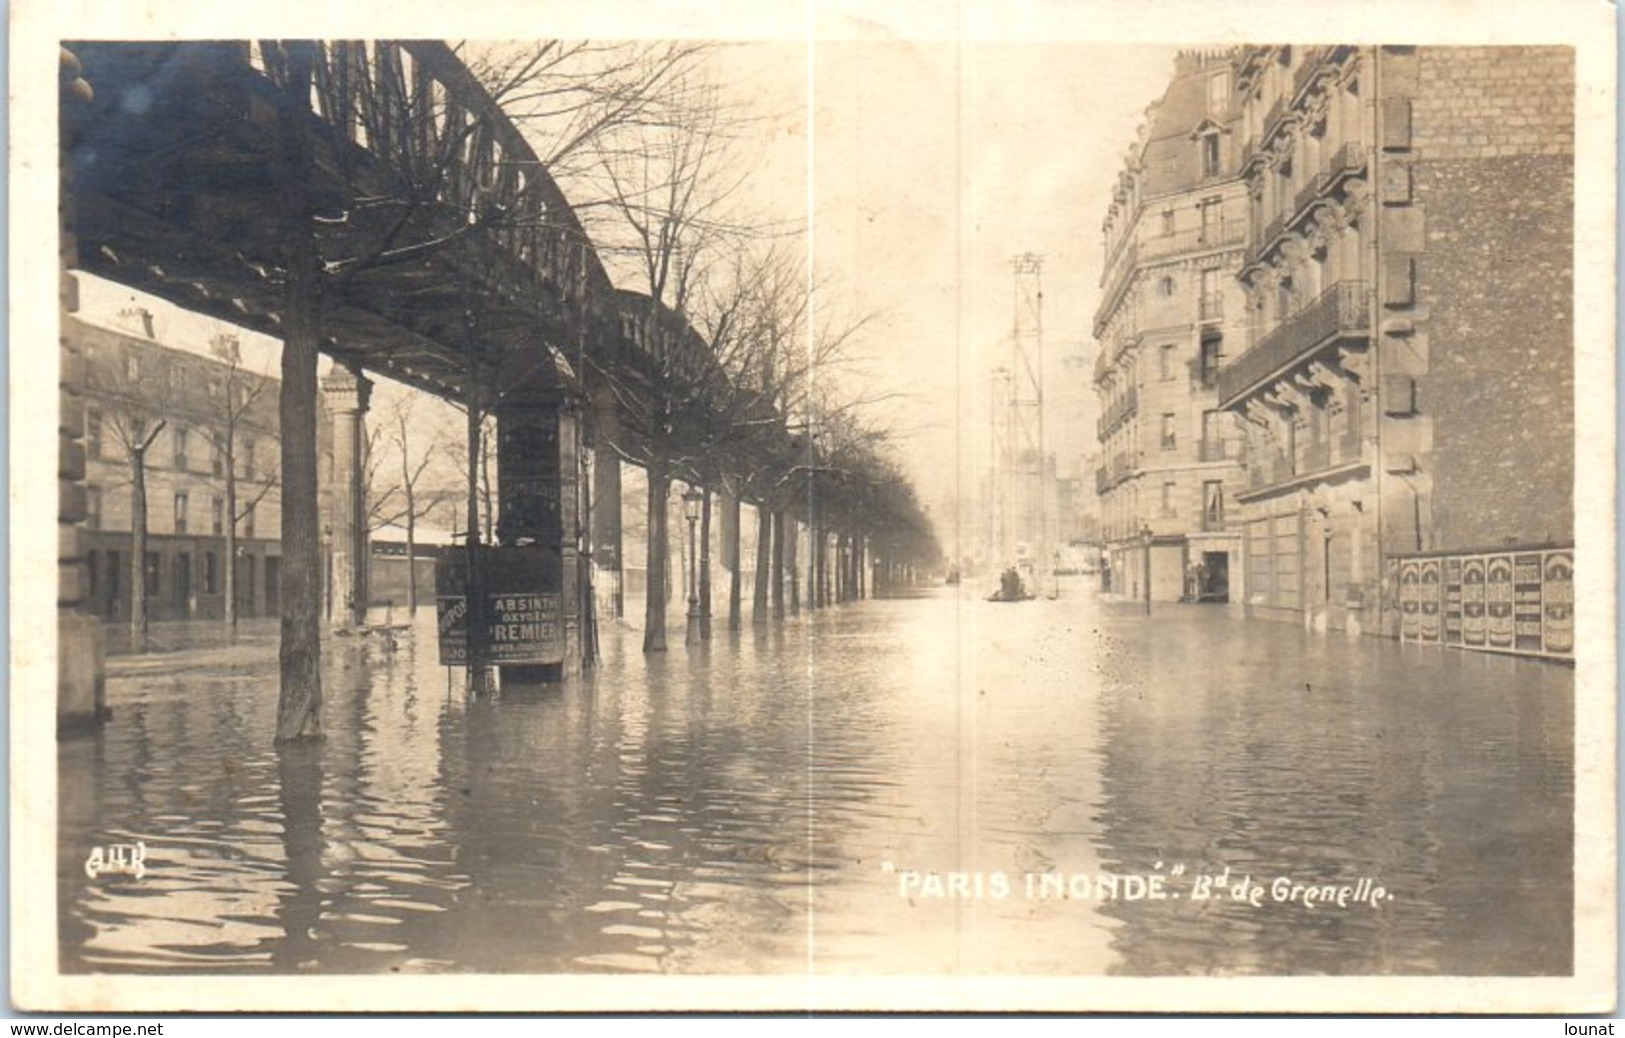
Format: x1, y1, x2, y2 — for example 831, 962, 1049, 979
1094, 50, 1248, 603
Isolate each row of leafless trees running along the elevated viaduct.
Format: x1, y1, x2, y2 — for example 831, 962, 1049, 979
146, 41, 928, 741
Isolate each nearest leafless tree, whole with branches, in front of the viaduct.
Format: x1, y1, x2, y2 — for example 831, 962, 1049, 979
255, 41, 711, 741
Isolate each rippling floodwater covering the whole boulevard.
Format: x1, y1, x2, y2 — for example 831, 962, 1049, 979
59, 578, 1573, 976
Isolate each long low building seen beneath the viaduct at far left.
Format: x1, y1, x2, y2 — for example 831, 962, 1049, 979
73, 312, 299, 621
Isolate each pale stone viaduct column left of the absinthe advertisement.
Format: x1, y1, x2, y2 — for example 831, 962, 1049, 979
322, 365, 372, 630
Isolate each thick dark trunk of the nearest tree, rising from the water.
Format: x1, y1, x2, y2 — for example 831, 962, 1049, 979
276, 42, 322, 742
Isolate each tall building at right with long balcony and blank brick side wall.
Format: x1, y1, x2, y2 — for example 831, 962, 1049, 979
1217, 45, 1575, 655
